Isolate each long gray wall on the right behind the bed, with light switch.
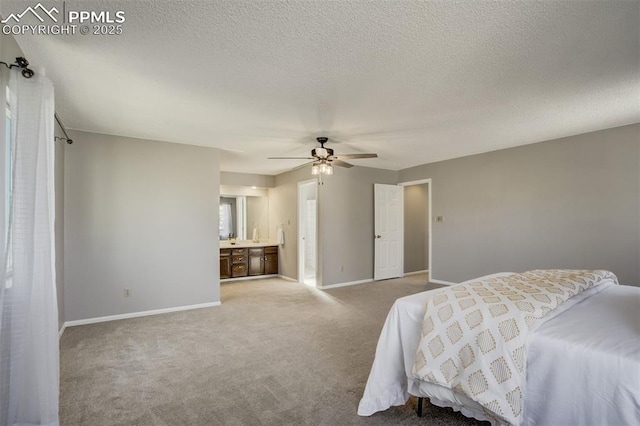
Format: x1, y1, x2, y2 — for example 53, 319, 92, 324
399, 124, 640, 285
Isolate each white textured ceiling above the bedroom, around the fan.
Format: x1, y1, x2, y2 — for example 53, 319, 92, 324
5, 0, 640, 174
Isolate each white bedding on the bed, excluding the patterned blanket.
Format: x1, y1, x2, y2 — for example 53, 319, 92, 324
358, 272, 640, 425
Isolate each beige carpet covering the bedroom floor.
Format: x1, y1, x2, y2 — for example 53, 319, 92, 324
60, 275, 478, 426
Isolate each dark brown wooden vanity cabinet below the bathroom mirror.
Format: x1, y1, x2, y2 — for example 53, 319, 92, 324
220, 246, 278, 279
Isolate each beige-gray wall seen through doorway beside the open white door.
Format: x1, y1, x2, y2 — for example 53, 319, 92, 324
404, 183, 430, 273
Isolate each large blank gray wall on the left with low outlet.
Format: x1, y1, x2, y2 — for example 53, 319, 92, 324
64, 132, 220, 321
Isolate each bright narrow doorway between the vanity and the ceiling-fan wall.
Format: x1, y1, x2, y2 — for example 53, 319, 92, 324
298, 179, 318, 287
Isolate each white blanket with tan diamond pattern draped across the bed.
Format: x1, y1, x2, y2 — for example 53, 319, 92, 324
413, 270, 617, 425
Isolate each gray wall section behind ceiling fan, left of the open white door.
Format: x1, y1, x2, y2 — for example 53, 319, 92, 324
318, 167, 398, 286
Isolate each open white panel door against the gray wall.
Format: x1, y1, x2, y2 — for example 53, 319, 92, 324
373, 183, 404, 281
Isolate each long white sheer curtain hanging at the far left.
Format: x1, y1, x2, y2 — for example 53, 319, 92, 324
0, 69, 59, 426
